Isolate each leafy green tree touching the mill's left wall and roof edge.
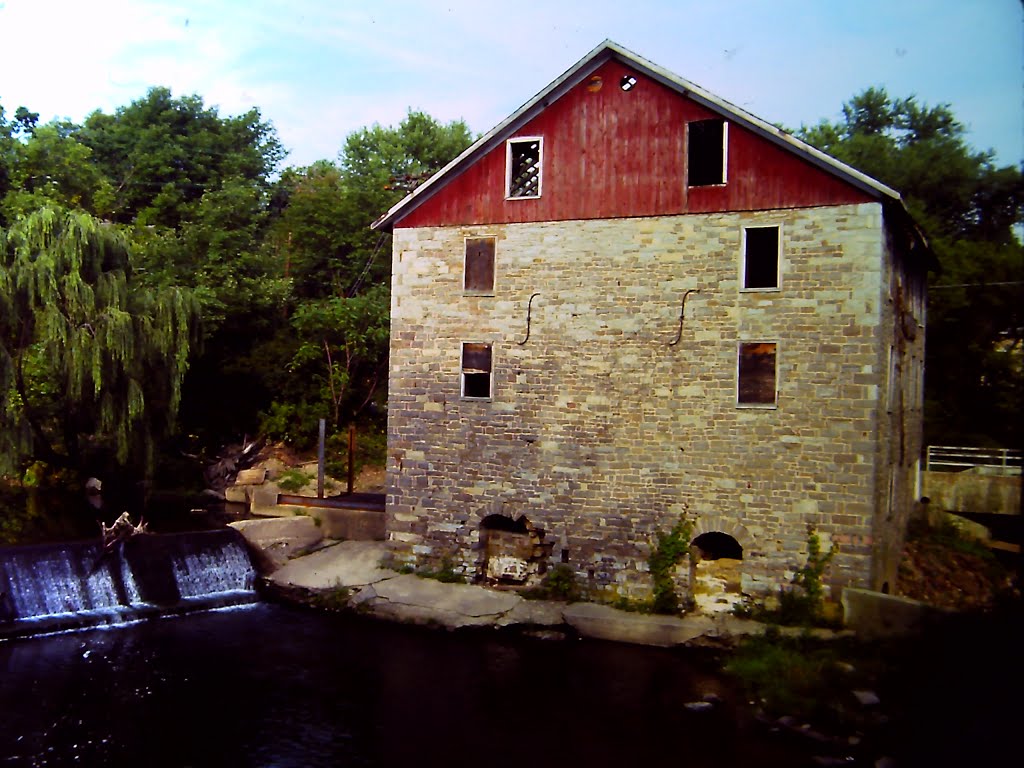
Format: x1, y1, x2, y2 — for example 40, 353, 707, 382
260, 112, 472, 442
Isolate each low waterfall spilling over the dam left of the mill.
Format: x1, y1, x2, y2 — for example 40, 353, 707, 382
0, 528, 256, 637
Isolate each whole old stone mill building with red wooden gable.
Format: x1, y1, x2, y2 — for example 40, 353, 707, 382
374, 41, 931, 596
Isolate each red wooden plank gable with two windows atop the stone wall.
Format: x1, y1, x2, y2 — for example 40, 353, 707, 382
393, 59, 879, 227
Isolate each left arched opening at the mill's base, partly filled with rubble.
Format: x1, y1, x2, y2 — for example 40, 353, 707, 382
480, 515, 551, 585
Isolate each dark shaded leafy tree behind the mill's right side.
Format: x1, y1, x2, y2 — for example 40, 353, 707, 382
799, 88, 1024, 445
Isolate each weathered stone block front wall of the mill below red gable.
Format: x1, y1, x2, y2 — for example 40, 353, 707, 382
387, 204, 888, 595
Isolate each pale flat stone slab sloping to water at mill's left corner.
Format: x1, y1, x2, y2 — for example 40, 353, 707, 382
270, 542, 398, 590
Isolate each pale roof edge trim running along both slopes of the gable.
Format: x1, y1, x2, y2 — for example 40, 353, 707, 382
371, 40, 905, 231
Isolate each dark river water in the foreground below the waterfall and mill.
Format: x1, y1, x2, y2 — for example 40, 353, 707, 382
0, 603, 807, 768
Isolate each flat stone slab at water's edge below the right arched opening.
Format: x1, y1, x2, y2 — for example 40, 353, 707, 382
562, 603, 716, 647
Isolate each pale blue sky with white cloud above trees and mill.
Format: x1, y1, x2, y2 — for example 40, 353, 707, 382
0, 0, 1024, 165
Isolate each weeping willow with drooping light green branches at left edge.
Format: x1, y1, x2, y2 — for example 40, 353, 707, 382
0, 208, 197, 474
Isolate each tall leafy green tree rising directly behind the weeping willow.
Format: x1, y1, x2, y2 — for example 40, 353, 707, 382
68, 88, 291, 446
